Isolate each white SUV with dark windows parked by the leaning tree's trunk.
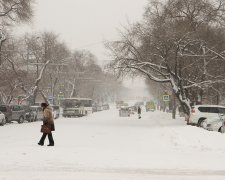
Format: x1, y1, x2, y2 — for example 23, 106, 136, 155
188, 105, 225, 127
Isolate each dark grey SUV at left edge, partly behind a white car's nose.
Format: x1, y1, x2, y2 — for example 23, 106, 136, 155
0, 105, 25, 123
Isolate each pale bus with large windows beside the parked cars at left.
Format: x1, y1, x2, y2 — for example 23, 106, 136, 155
61, 98, 92, 117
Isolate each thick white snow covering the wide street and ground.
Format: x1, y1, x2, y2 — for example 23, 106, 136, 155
0, 106, 225, 180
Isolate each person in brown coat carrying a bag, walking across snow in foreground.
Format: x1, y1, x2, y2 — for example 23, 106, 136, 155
38, 103, 55, 146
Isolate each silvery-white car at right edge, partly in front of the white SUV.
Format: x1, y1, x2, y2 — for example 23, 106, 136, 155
206, 118, 224, 133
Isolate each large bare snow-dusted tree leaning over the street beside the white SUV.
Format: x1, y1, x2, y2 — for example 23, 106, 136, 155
107, 0, 225, 119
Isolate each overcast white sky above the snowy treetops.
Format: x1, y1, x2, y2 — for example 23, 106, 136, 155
17, 0, 147, 63
